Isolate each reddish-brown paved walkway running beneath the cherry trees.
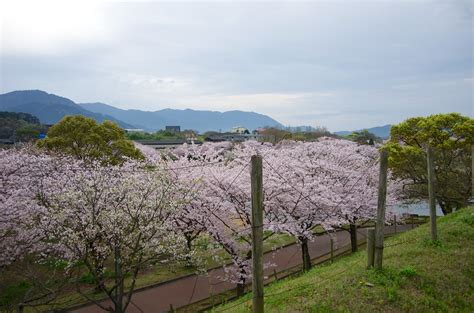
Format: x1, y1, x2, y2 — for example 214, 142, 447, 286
72, 225, 411, 313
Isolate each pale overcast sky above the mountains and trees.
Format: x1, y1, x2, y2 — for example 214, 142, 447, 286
0, 0, 474, 131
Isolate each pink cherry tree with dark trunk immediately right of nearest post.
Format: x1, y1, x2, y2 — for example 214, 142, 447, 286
264, 141, 341, 271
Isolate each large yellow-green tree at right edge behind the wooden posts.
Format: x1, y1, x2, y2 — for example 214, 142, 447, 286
386, 113, 474, 214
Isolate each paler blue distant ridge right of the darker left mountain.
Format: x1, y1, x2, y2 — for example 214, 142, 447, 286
80, 103, 283, 132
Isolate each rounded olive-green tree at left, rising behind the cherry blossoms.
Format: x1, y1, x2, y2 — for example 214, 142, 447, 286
38, 115, 143, 164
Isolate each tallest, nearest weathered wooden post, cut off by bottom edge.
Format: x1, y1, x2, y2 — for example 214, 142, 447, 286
250, 155, 263, 313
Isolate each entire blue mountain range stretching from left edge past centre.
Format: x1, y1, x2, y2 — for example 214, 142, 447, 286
0, 90, 283, 132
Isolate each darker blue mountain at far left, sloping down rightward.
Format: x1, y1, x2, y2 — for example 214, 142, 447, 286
0, 90, 134, 128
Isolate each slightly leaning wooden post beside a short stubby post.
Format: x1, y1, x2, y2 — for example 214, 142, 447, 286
374, 150, 388, 269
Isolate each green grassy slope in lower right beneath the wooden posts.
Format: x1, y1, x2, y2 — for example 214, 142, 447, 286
215, 207, 474, 312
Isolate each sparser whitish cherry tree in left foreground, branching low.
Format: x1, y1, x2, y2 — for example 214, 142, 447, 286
35, 161, 184, 312
